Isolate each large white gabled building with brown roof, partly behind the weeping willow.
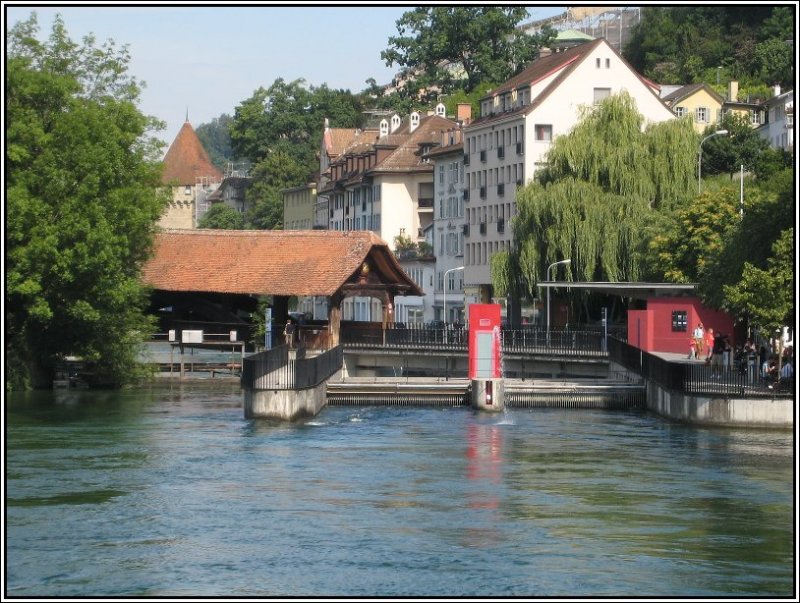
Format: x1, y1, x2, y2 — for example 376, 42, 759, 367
464, 39, 675, 304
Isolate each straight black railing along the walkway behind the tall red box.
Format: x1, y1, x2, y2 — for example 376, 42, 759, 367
340, 323, 607, 356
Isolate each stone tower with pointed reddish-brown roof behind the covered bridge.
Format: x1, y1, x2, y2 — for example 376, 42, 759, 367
159, 119, 222, 228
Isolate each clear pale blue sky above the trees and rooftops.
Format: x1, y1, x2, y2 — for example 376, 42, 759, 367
4, 2, 564, 150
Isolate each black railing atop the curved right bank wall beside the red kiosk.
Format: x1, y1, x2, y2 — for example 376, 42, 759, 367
608, 337, 795, 398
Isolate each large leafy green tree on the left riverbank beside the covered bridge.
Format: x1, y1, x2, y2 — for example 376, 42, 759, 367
5, 14, 166, 388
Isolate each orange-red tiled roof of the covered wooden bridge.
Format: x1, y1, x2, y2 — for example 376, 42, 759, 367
142, 230, 422, 296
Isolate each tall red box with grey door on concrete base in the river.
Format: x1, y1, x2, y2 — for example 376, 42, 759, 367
469, 304, 505, 410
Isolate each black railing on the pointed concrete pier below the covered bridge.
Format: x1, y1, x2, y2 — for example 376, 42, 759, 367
241, 345, 344, 390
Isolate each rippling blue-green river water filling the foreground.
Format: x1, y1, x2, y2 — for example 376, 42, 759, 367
5, 383, 795, 597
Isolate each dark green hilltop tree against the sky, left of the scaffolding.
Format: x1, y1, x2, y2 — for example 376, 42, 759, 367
381, 6, 555, 93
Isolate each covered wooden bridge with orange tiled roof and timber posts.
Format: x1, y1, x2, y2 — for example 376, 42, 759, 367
142, 230, 424, 346
